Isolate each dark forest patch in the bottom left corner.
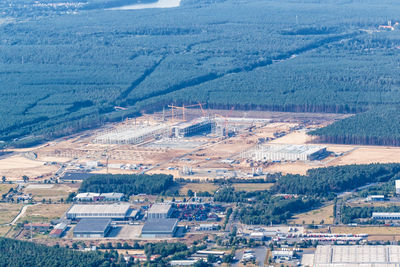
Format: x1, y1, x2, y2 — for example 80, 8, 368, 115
0, 237, 119, 267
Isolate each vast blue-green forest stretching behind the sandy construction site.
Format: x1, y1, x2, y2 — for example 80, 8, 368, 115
0, 0, 400, 146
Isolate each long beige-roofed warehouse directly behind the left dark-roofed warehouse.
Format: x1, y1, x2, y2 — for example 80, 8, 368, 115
67, 204, 131, 220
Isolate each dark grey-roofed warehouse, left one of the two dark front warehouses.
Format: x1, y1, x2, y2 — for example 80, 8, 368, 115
74, 219, 111, 238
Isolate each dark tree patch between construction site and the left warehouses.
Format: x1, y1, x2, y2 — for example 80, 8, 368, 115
79, 174, 174, 197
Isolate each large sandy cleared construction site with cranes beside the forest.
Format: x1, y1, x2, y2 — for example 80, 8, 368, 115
0, 103, 400, 181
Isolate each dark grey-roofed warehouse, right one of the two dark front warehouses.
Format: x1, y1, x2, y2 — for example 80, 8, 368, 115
142, 219, 178, 238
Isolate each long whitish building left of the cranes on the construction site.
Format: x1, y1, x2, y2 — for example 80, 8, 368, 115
93, 124, 170, 145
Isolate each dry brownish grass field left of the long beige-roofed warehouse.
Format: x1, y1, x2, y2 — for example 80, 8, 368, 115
20, 204, 70, 222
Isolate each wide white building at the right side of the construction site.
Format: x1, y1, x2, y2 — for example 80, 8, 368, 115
242, 144, 326, 162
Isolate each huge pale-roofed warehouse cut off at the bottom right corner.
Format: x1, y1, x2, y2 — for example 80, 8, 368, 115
308, 246, 400, 267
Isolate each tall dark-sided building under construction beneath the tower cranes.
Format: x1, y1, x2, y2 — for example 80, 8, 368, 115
172, 118, 215, 138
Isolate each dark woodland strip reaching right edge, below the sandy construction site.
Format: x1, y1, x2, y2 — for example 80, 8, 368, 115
271, 164, 400, 197
